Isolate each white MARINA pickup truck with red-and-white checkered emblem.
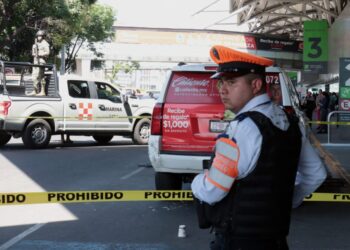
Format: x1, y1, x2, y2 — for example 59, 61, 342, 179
0, 61, 155, 148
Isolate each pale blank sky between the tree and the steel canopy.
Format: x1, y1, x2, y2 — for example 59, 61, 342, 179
98, 0, 246, 31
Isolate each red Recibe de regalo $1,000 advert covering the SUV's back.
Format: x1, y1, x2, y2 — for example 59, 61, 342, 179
162, 72, 224, 153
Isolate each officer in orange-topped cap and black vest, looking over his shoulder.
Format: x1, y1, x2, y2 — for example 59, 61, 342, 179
191, 46, 326, 250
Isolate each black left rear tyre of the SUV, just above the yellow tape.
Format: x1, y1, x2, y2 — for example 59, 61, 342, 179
155, 172, 182, 190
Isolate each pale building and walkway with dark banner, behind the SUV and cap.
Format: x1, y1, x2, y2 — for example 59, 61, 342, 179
77, 26, 302, 90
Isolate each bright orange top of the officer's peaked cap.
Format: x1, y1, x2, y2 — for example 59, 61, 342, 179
210, 45, 273, 67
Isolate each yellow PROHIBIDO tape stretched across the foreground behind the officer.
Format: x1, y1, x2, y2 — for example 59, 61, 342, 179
0, 190, 350, 206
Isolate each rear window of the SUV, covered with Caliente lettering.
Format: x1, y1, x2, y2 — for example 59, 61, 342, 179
165, 72, 221, 104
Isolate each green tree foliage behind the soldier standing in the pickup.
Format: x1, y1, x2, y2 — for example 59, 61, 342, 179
0, 0, 114, 68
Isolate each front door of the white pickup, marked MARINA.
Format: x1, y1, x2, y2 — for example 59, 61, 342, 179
93, 82, 132, 131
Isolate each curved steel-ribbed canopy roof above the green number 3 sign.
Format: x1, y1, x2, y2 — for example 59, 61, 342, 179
194, 0, 347, 40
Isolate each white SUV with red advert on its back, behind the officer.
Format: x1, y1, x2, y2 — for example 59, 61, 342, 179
148, 65, 305, 190
